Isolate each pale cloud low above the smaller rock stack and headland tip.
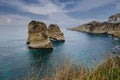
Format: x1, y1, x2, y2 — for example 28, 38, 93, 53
43, 13, 94, 27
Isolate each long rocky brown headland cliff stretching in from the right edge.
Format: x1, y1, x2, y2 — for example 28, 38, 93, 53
71, 14, 120, 38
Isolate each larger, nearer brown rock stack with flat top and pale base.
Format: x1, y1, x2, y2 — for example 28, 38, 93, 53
27, 21, 53, 49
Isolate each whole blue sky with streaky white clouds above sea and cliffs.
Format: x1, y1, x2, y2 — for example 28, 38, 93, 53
0, 0, 120, 27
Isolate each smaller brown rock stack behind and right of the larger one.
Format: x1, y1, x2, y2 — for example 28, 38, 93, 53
47, 24, 65, 42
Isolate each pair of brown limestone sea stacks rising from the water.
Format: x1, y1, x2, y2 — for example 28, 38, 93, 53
27, 20, 65, 49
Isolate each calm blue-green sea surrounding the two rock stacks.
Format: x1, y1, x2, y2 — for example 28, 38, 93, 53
0, 27, 120, 80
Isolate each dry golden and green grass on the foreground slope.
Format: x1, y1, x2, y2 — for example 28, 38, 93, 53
24, 55, 120, 80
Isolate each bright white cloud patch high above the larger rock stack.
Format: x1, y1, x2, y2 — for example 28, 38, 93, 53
20, 4, 60, 15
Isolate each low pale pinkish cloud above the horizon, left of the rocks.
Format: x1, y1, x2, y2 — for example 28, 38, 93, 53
0, 15, 31, 26
